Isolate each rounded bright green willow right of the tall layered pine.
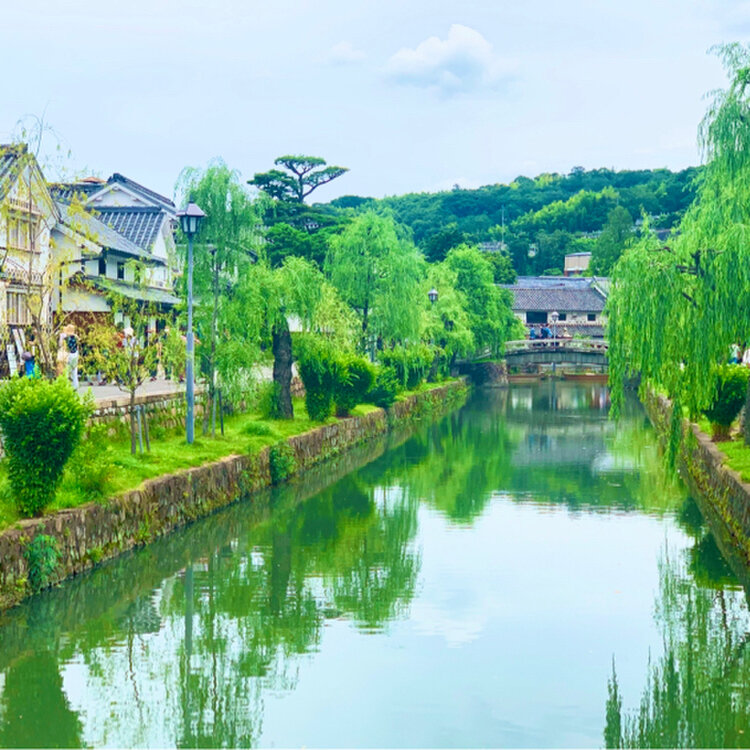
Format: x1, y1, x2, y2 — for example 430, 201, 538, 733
325, 211, 425, 346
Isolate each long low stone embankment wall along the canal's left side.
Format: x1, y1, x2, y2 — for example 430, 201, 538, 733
0, 381, 468, 609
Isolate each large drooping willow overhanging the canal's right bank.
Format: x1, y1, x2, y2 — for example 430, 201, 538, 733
608, 44, 750, 414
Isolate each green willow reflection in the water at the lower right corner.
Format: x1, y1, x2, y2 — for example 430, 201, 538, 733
604, 520, 750, 747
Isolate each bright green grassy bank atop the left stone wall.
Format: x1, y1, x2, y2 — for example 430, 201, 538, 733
0, 382, 445, 529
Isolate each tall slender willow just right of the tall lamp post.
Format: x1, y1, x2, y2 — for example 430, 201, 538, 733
178, 160, 260, 434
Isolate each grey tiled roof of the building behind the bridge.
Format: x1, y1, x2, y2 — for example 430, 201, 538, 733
503, 276, 606, 313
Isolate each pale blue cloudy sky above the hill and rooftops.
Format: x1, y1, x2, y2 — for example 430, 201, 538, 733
0, 0, 750, 201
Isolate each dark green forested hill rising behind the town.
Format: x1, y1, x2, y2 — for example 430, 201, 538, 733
320, 167, 700, 274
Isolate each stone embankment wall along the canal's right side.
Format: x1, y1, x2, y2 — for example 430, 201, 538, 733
643, 393, 750, 566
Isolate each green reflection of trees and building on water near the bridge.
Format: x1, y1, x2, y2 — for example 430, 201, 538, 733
376, 382, 684, 523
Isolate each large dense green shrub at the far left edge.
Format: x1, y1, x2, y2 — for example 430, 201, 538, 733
0, 378, 91, 516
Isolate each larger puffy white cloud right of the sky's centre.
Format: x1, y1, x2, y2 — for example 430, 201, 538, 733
385, 24, 516, 94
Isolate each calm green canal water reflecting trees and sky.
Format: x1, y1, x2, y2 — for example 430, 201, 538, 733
0, 382, 750, 747
